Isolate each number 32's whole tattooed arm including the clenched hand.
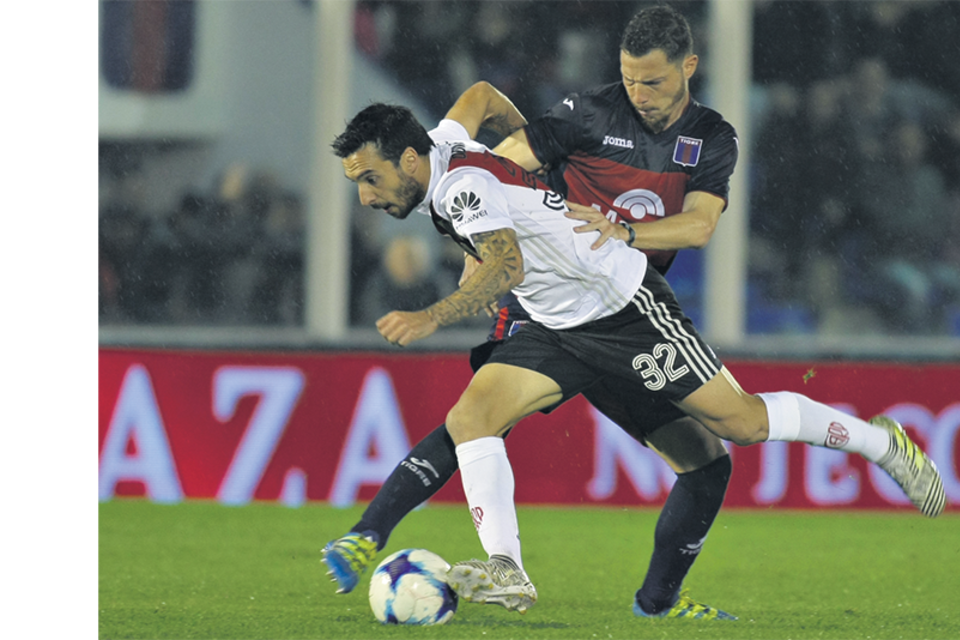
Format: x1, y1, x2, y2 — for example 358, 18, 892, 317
377, 229, 523, 347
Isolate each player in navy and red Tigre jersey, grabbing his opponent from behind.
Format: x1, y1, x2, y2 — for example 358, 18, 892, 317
323, 5, 738, 619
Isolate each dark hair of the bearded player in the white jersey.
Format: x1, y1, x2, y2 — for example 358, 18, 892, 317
331, 103, 433, 166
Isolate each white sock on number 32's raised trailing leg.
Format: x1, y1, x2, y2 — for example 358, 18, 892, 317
758, 391, 890, 462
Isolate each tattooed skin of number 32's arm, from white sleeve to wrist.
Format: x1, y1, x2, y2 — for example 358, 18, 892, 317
427, 229, 523, 326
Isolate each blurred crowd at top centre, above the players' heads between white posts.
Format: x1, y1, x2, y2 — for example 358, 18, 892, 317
355, 0, 707, 124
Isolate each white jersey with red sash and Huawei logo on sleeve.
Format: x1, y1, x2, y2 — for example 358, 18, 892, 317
417, 120, 647, 329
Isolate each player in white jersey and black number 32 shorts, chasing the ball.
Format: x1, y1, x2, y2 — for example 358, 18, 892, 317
333, 99, 945, 612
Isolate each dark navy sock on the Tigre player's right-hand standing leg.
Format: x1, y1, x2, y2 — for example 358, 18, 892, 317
636, 456, 733, 613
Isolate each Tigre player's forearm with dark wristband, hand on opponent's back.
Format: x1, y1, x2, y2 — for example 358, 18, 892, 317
566, 191, 726, 250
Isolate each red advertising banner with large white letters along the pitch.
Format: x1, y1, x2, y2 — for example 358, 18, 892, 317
97, 348, 960, 510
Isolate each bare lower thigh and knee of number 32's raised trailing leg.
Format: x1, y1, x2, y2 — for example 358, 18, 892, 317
676, 367, 768, 445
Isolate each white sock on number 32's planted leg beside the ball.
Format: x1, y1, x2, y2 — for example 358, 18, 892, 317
457, 436, 523, 569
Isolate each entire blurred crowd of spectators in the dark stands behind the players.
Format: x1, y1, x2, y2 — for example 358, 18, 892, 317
97, 0, 960, 335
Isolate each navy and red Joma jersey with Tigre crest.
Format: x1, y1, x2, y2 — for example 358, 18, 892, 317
526, 82, 737, 273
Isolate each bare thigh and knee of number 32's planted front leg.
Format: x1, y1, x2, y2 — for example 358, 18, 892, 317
447, 363, 563, 444
